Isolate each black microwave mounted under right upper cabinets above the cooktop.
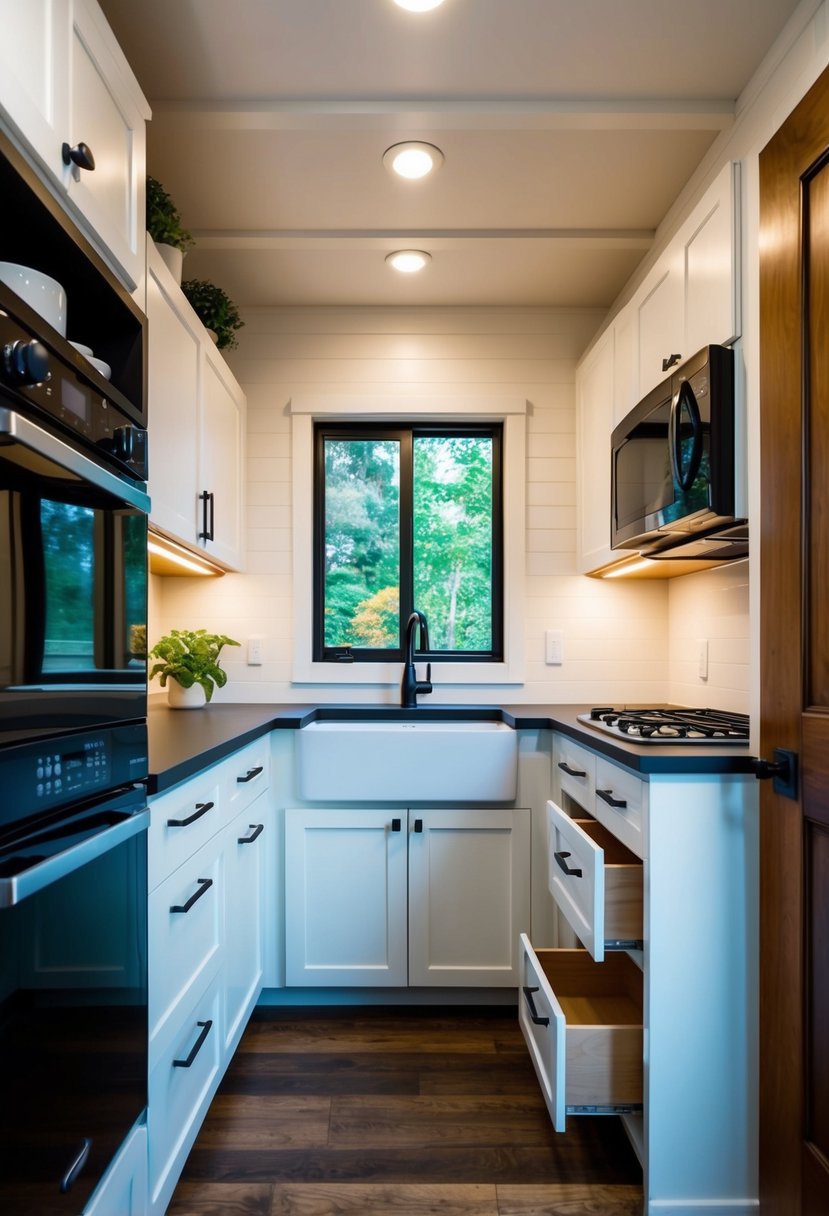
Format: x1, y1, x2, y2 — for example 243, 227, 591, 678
610, 345, 749, 561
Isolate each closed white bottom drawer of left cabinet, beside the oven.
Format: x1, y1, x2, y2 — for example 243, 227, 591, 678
147, 979, 222, 1211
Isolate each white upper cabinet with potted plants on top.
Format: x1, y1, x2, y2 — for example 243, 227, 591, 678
147, 241, 246, 570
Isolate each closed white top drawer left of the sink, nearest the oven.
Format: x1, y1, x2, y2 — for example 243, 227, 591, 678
148, 767, 226, 891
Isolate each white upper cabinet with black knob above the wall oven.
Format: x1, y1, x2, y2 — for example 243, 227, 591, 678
0, 0, 150, 291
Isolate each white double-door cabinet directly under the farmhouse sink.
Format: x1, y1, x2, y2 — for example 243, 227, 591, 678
286, 807, 530, 987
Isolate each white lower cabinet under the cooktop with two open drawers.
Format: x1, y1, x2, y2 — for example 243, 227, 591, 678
519, 734, 758, 1216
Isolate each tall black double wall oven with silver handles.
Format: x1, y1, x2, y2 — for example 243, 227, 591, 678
0, 278, 148, 1216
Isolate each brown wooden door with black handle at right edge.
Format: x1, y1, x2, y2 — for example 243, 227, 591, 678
760, 59, 829, 1216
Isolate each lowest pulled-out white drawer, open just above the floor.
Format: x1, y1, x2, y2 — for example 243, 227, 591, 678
518, 934, 643, 1132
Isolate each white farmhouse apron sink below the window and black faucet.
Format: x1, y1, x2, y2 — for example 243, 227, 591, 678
297, 721, 518, 803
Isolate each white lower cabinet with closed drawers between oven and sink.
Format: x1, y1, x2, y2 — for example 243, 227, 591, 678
147, 736, 269, 1216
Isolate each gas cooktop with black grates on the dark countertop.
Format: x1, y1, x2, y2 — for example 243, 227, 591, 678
579, 705, 749, 745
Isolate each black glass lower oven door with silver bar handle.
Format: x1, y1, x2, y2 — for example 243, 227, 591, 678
0, 786, 150, 1216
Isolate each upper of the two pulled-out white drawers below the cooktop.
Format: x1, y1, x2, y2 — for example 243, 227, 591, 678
547, 803, 642, 963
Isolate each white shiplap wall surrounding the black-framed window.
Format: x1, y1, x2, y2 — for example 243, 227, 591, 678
150, 308, 669, 704
